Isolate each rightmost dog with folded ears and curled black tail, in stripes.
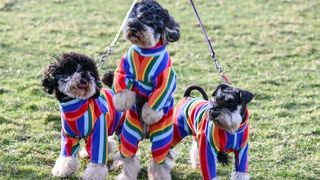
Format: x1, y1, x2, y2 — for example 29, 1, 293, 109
172, 84, 254, 180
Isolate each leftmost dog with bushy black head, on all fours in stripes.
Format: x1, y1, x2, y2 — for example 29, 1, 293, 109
42, 53, 125, 179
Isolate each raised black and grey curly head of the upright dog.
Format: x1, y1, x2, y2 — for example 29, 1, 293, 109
124, 0, 180, 48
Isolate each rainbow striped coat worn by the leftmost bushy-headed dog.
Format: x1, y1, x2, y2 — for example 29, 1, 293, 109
60, 89, 125, 164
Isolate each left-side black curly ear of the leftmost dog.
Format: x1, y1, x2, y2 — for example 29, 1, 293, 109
41, 63, 58, 94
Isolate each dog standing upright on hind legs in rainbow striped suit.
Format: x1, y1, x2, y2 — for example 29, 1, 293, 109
113, 0, 180, 180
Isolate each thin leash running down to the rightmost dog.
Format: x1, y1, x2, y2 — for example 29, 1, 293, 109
190, 0, 231, 84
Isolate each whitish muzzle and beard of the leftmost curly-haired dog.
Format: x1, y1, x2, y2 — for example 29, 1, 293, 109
58, 72, 96, 99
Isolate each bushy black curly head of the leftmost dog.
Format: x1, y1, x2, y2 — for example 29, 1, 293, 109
42, 53, 101, 102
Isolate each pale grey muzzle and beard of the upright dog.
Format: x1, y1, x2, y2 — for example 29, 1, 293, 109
125, 26, 160, 48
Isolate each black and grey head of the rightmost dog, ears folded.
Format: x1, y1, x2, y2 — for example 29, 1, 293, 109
209, 84, 254, 134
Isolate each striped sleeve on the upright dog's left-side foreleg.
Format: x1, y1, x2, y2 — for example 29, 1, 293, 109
112, 56, 133, 93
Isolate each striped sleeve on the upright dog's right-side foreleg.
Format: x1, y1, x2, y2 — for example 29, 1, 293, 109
148, 66, 176, 111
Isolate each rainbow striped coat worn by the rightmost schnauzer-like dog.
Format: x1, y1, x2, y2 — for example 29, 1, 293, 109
172, 97, 249, 180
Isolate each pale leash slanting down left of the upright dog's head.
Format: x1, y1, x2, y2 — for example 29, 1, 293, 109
97, 0, 138, 67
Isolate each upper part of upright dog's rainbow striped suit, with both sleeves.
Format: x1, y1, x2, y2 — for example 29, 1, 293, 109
113, 42, 176, 114
